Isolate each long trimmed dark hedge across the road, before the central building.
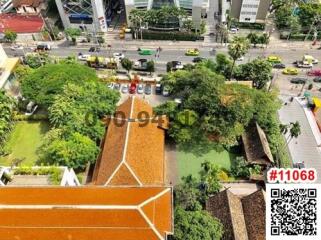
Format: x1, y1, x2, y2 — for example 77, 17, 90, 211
138, 31, 204, 41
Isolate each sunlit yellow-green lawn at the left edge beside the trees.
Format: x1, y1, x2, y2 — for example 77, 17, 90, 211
0, 121, 49, 166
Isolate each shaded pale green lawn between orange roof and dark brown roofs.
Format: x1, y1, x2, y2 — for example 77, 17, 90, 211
176, 147, 239, 179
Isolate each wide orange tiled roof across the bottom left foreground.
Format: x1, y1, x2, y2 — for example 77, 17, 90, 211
0, 187, 172, 240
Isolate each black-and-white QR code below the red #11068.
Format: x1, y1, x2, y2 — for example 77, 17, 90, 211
266, 184, 321, 239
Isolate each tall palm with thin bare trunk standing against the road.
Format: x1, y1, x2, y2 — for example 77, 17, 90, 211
228, 37, 250, 80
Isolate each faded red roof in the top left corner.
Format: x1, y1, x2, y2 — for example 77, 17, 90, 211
0, 14, 44, 33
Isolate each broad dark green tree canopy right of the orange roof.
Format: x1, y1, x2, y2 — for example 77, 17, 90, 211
159, 60, 280, 150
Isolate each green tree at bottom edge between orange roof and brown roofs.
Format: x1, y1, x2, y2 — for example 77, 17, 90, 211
174, 207, 223, 240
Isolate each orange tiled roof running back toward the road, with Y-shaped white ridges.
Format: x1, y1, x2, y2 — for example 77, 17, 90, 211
93, 97, 168, 186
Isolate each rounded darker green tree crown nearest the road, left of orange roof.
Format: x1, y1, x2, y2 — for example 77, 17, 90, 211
21, 63, 98, 107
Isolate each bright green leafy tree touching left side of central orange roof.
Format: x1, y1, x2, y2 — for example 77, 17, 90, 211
49, 82, 119, 142
